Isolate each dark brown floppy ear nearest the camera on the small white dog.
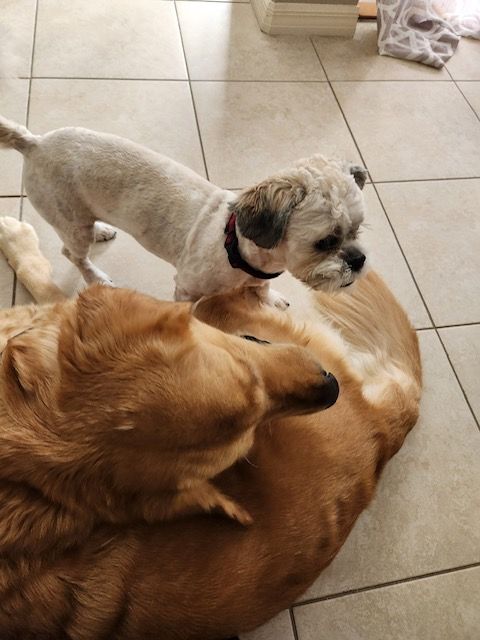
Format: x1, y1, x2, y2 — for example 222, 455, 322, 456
230, 176, 307, 249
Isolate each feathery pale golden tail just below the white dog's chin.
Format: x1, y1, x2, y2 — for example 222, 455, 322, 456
314, 271, 422, 427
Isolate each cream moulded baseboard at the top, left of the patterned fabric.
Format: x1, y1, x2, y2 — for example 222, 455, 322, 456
251, 0, 358, 38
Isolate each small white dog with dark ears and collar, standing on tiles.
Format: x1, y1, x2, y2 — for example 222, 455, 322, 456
0, 118, 366, 307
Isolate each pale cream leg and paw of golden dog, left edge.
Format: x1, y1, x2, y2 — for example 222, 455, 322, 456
0, 216, 66, 304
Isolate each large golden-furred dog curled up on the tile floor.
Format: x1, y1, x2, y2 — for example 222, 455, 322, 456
0, 216, 421, 640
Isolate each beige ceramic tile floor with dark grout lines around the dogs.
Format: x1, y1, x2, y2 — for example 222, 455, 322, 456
0, 0, 480, 640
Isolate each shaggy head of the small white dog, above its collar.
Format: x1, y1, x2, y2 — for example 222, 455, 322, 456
231, 155, 367, 292
